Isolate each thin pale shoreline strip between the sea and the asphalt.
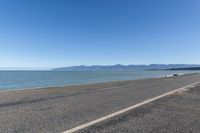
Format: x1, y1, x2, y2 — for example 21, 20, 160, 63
0, 73, 198, 93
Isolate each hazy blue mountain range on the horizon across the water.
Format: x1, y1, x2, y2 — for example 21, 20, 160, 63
52, 64, 200, 71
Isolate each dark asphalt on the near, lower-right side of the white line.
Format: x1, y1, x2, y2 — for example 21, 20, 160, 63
79, 82, 200, 133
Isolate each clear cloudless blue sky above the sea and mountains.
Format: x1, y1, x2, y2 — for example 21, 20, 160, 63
0, 0, 200, 68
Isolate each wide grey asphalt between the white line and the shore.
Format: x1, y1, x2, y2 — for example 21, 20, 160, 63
0, 74, 200, 133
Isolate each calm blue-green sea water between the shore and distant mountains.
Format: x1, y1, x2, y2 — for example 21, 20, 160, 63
0, 70, 199, 90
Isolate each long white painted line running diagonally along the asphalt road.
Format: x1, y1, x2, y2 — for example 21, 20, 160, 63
62, 81, 200, 133
